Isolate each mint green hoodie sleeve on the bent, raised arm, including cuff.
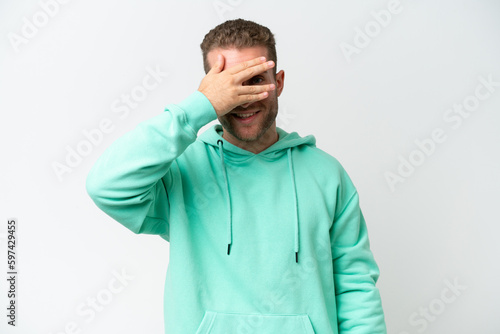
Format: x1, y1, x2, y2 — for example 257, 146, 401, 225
86, 91, 217, 240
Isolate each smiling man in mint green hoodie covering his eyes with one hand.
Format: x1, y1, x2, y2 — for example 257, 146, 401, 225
87, 19, 386, 334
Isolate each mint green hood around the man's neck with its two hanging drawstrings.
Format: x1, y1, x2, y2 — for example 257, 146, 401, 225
199, 124, 316, 263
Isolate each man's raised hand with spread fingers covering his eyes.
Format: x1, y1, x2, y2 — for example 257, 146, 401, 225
198, 54, 276, 117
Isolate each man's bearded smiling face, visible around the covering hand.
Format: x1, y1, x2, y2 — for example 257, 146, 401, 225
207, 46, 284, 142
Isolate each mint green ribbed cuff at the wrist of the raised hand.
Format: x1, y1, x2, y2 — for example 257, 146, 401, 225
177, 91, 217, 133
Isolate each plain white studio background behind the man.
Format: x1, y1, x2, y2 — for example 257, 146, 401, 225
0, 0, 500, 334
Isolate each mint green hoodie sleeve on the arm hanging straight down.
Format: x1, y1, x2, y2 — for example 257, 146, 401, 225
330, 171, 387, 334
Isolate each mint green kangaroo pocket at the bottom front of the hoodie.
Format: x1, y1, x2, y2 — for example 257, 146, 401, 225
196, 311, 314, 334
